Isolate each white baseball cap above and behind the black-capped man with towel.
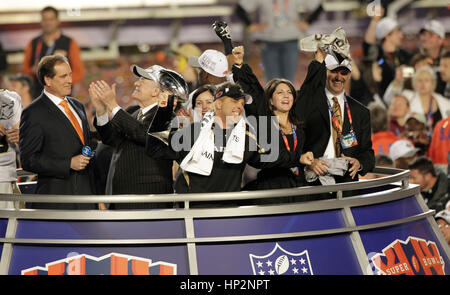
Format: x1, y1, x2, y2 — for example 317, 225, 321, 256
188, 49, 228, 77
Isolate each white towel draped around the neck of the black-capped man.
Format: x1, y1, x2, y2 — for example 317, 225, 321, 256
180, 112, 246, 176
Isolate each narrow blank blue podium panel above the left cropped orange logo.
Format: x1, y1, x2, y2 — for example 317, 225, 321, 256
16, 220, 186, 239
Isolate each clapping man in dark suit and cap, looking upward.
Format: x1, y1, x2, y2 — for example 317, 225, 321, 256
89, 65, 187, 209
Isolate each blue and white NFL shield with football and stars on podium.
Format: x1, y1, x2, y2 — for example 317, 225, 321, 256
249, 243, 313, 275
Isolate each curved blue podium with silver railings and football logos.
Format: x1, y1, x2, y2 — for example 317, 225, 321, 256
0, 168, 450, 275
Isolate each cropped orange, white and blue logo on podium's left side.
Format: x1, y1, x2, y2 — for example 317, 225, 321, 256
22, 253, 177, 275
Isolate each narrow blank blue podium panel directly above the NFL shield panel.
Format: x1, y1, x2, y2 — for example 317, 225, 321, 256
194, 210, 345, 237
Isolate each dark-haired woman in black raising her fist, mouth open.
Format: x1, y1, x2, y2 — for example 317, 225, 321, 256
232, 46, 313, 190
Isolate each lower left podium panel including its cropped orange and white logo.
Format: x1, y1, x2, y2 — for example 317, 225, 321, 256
9, 245, 189, 275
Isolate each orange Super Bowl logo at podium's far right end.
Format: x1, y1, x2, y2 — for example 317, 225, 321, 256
371, 236, 445, 275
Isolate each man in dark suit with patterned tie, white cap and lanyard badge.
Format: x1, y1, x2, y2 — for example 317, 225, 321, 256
294, 46, 375, 188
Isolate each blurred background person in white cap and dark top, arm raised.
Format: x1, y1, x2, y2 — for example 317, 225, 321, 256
362, 9, 411, 97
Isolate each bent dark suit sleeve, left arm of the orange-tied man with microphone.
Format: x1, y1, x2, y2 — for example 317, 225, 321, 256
19, 108, 71, 178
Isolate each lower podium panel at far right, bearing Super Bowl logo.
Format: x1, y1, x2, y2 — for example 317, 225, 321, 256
360, 219, 450, 275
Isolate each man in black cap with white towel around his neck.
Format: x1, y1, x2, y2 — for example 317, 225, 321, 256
147, 82, 300, 193
